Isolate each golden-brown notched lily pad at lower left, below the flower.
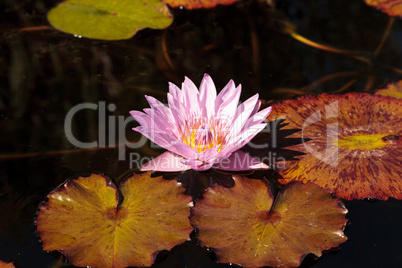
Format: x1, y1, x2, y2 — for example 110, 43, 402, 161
36, 173, 192, 267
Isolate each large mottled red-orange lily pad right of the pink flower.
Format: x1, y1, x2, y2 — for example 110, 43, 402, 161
268, 93, 402, 200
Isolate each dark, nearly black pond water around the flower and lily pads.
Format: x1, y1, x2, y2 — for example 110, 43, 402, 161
0, 0, 402, 268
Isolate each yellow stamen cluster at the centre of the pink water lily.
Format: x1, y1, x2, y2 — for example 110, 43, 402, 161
179, 118, 229, 153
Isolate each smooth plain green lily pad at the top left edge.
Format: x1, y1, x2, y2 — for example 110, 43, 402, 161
47, 0, 172, 40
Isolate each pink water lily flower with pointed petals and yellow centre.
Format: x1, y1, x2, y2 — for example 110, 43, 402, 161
130, 74, 271, 171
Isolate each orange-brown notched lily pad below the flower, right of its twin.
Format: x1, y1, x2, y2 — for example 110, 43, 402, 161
191, 176, 347, 267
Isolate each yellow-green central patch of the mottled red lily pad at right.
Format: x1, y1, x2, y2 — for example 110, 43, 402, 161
338, 134, 387, 150
